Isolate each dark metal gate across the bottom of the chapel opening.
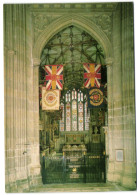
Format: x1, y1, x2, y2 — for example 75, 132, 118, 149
42, 154, 106, 183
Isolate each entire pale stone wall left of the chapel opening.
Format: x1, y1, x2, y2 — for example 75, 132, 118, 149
4, 5, 40, 192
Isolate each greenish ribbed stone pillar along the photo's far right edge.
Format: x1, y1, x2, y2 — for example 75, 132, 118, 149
121, 3, 136, 188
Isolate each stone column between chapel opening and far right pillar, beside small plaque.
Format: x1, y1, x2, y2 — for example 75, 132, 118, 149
107, 4, 123, 183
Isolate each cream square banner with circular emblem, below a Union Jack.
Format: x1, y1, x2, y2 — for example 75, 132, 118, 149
42, 87, 60, 111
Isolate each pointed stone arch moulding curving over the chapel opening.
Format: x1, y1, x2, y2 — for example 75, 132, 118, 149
33, 14, 112, 65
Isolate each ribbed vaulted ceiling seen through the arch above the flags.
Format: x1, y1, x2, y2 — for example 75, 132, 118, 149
40, 26, 106, 91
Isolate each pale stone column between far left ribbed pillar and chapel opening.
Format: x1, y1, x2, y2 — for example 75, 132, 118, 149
25, 5, 42, 188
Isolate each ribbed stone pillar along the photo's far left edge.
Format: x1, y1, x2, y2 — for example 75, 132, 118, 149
4, 5, 28, 192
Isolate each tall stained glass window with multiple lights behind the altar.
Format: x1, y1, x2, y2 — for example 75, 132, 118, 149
60, 89, 90, 131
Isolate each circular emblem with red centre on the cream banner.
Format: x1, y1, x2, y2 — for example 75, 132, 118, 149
44, 91, 57, 107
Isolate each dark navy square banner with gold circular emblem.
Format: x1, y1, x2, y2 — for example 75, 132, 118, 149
87, 87, 104, 108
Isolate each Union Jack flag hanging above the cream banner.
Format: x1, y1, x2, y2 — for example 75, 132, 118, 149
45, 65, 63, 90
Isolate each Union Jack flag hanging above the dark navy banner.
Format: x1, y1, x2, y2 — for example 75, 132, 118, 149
83, 63, 101, 88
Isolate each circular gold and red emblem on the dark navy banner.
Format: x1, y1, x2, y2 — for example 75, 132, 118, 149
89, 89, 103, 106
